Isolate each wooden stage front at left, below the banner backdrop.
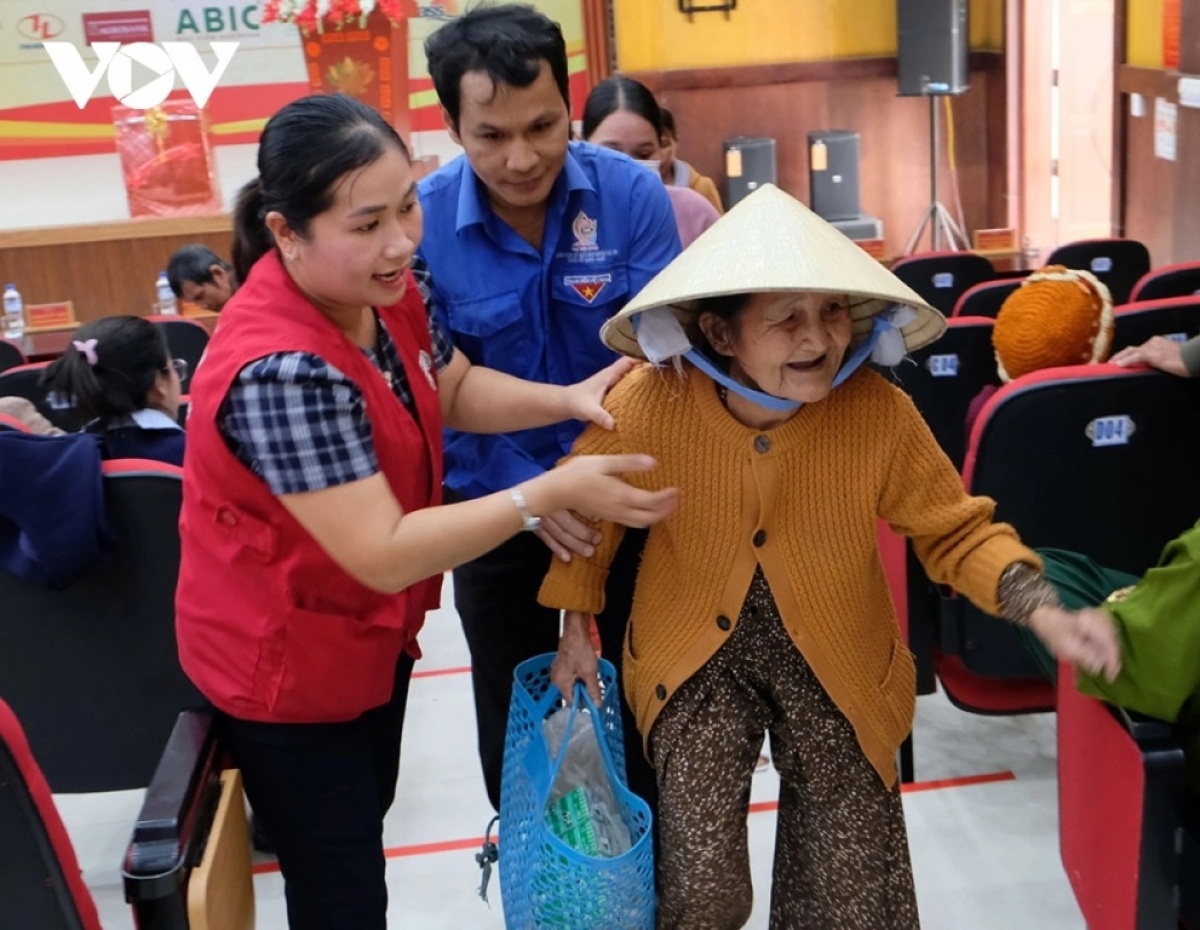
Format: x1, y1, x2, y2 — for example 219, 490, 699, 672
0, 216, 230, 323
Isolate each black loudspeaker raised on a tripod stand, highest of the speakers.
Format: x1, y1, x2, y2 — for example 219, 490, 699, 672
896, 0, 971, 97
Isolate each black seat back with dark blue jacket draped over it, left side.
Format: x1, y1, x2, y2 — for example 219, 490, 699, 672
0, 460, 202, 792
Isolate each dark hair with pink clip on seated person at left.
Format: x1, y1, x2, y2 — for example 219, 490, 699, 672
42, 317, 170, 428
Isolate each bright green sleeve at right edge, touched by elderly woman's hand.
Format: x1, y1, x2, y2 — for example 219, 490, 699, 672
1076, 523, 1200, 722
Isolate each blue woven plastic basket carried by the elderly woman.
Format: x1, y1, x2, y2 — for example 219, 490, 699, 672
499, 654, 654, 930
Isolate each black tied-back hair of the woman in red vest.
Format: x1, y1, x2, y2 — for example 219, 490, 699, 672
233, 94, 409, 281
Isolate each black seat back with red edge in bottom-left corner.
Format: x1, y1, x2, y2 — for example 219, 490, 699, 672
0, 701, 101, 930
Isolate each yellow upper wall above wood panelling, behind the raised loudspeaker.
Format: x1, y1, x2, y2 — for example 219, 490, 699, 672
613, 0, 1003, 71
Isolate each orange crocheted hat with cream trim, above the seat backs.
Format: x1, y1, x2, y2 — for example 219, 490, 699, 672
991, 265, 1112, 382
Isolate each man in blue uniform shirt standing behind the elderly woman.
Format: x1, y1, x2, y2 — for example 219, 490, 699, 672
419, 5, 680, 808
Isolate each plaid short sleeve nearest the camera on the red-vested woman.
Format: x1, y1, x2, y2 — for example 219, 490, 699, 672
218, 352, 379, 494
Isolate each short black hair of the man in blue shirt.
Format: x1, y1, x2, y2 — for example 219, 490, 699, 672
425, 4, 571, 131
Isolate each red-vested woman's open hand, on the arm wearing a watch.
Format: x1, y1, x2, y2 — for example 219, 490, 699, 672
522, 455, 679, 527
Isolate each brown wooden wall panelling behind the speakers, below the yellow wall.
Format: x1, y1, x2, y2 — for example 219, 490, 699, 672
632, 54, 1007, 254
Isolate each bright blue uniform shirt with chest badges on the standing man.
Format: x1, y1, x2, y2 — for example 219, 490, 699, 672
418, 143, 680, 497
